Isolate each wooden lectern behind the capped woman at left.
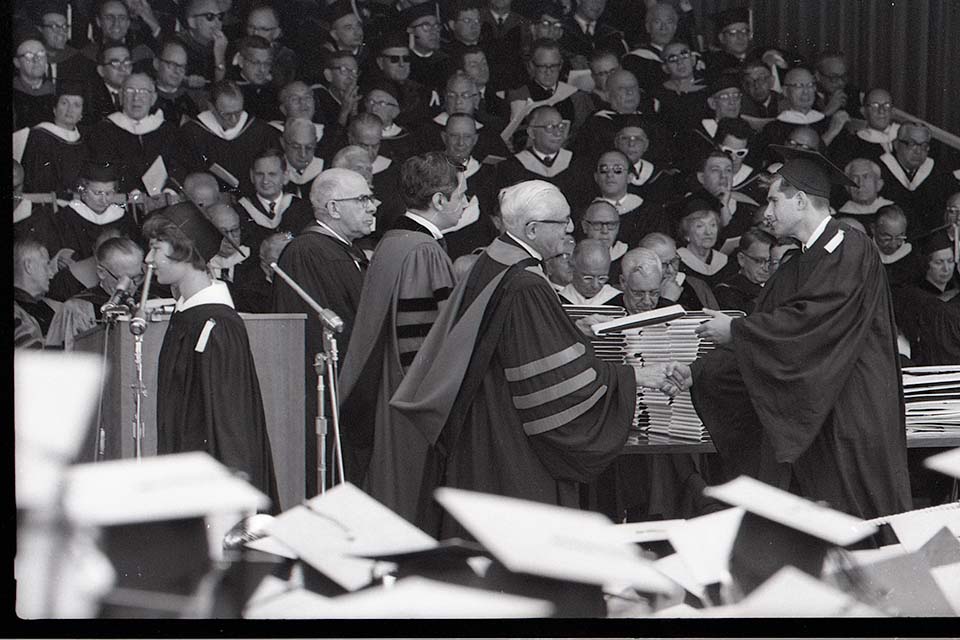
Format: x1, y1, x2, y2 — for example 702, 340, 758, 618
76, 313, 306, 511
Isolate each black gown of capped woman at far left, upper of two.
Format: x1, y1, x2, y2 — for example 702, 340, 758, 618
21, 127, 90, 193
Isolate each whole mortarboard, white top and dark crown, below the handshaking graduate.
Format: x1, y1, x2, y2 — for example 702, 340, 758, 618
704, 476, 877, 594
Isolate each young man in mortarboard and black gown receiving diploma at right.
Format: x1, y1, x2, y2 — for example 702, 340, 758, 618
691, 147, 911, 518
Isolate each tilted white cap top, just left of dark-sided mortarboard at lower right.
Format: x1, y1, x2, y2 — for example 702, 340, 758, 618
670, 508, 744, 586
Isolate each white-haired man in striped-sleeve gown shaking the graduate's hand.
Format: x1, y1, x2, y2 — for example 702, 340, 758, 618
391, 180, 689, 536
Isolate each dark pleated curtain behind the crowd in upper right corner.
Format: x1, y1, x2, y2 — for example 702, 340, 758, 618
691, 0, 960, 134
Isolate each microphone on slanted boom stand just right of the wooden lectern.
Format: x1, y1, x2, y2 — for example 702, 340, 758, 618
270, 262, 344, 494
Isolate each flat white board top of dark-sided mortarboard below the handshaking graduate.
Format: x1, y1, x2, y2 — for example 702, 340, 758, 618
703, 476, 877, 547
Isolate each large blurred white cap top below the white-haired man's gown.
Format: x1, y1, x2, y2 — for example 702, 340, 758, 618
435, 487, 675, 594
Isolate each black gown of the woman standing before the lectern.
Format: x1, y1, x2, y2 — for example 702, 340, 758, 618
157, 294, 279, 509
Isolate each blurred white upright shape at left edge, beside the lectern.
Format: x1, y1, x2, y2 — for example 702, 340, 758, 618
13, 351, 102, 509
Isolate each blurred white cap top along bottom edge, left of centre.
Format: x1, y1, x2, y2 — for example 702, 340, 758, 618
245, 577, 553, 618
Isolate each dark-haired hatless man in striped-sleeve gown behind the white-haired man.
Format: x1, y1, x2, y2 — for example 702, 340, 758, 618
340, 151, 467, 522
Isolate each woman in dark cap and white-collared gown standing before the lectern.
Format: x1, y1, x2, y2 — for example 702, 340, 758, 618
143, 202, 278, 505
